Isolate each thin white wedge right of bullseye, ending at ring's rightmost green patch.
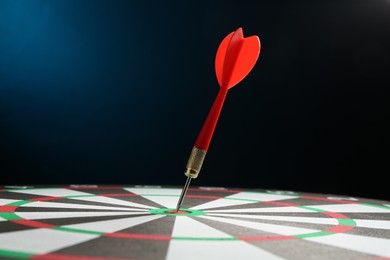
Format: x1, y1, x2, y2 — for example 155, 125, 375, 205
207, 213, 339, 225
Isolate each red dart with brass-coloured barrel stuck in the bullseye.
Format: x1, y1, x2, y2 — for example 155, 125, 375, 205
176, 28, 260, 211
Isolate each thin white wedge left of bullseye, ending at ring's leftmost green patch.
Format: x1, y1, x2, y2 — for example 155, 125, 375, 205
15, 211, 145, 221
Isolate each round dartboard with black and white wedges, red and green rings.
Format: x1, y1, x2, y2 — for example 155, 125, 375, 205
0, 185, 390, 260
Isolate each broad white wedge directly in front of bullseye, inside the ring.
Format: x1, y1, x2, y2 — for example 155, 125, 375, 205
172, 217, 233, 239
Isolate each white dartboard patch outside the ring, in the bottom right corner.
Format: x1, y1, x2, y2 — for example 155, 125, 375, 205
305, 233, 390, 257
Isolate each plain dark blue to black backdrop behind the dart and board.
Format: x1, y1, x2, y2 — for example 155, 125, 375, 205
0, 0, 390, 199
